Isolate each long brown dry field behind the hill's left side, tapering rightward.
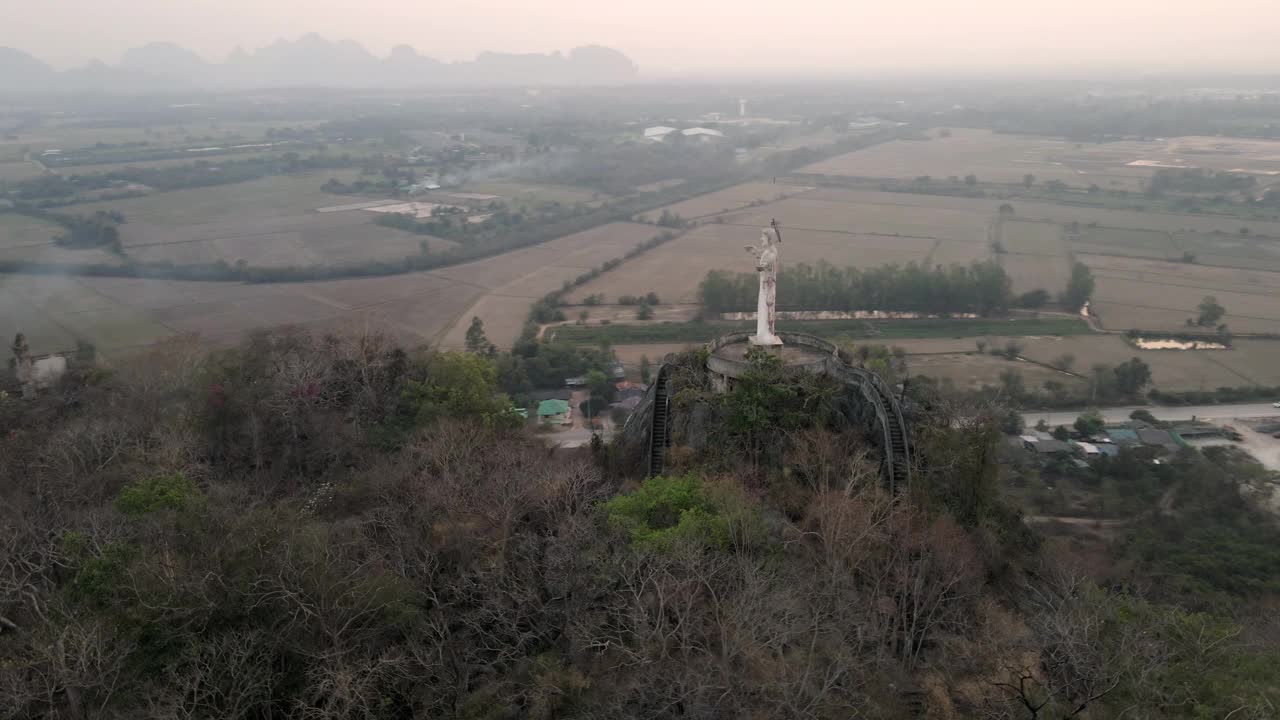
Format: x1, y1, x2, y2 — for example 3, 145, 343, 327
0, 223, 655, 359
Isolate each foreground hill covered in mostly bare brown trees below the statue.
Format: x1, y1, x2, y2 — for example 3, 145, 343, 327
0, 333, 1280, 720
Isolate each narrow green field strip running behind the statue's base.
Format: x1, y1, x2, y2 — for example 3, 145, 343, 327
547, 318, 1092, 345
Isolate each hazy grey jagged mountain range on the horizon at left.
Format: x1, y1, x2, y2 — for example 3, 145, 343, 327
0, 33, 637, 92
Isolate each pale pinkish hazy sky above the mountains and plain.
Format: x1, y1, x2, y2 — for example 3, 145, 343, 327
0, 0, 1280, 74
